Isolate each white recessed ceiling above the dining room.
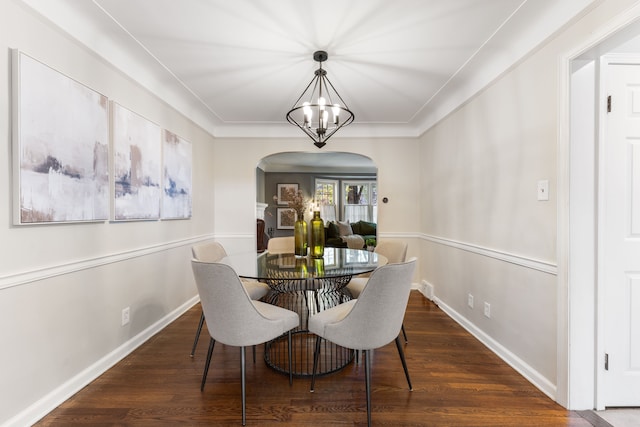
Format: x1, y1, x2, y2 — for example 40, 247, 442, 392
23, 0, 594, 138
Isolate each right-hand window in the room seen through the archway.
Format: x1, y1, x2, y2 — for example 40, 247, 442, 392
342, 181, 378, 222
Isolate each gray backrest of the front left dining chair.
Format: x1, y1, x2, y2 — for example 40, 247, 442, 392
191, 259, 280, 346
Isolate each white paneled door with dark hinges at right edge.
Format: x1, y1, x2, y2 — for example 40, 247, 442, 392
598, 64, 640, 407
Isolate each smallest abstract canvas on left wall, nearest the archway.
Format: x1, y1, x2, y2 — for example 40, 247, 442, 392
162, 130, 192, 219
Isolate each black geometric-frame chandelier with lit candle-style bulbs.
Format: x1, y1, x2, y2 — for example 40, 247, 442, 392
287, 50, 355, 148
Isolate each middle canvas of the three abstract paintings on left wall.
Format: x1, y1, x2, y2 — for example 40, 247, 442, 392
111, 102, 162, 221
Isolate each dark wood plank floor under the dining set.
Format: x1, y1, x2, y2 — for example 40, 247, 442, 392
37, 291, 591, 427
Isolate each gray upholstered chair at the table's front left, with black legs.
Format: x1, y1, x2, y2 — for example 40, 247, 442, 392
191, 260, 300, 425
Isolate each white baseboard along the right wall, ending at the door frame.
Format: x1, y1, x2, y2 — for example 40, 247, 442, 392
433, 297, 557, 401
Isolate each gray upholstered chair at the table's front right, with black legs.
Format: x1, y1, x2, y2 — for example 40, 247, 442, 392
309, 258, 416, 425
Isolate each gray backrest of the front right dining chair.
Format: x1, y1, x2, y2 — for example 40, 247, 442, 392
325, 258, 416, 350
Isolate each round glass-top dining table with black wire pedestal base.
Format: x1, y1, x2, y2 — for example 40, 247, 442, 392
219, 248, 388, 377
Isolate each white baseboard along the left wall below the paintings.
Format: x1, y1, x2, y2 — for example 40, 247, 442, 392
3, 296, 200, 427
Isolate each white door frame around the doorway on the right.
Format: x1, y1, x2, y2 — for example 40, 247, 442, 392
556, 4, 640, 410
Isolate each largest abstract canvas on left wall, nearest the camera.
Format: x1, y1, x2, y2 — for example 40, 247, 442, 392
12, 50, 109, 225
